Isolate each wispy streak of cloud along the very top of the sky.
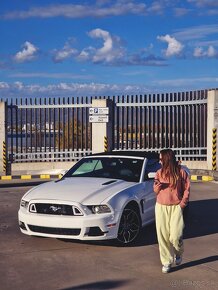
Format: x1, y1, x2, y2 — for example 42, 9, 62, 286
1, 0, 218, 19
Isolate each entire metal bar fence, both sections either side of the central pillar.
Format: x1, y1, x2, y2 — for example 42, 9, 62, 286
4, 90, 207, 162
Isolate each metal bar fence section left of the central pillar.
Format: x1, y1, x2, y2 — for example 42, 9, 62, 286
7, 97, 92, 162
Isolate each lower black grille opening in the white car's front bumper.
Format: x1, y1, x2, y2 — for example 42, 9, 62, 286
28, 225, 81, 236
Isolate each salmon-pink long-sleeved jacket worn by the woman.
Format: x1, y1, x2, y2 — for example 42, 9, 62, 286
154, 168, 190, 208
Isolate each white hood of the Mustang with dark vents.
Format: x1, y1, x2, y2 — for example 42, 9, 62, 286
23, 177, 135, 205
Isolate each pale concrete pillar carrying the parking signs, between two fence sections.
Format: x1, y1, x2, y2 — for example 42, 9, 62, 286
89, 99, 113, 153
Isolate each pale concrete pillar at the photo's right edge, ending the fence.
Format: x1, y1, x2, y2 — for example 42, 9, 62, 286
207, 89, 218, 170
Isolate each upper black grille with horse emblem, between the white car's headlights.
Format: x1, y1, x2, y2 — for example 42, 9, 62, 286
30, 203, 74, 215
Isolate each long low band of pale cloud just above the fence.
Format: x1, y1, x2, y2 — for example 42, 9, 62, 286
0, 76, 218, 98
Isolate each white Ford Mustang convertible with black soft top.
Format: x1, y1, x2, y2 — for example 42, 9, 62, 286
18, 151, 160, 244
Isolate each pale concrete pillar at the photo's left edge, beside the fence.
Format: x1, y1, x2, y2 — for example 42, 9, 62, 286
0, 102, 7, 175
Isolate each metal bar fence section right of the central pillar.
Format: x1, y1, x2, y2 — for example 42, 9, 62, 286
111, 90, 207, 160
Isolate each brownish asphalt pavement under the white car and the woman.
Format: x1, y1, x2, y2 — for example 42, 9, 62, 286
0, 181, 218, 290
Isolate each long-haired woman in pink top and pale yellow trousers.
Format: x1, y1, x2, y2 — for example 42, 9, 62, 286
154, 149, 190, 273
